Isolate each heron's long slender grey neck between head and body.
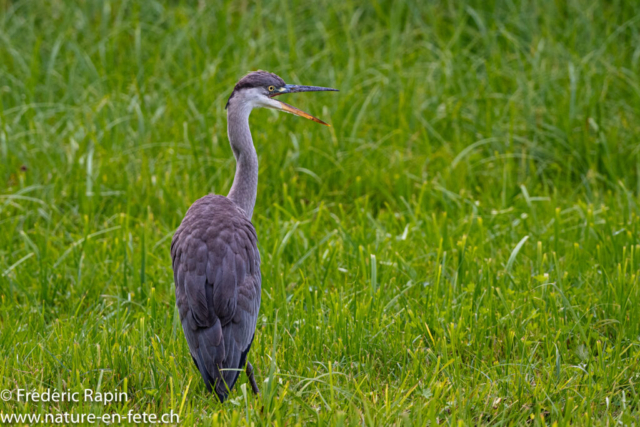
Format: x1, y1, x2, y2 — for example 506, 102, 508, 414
227, 103, 258, 219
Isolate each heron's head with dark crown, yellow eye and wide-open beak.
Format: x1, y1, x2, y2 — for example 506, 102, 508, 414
225, 71, 338, 126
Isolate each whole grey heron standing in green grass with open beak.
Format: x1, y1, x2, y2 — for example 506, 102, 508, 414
171, 71, 336, 402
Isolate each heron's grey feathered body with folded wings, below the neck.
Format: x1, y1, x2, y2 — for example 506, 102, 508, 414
171, 195, 261, 401
